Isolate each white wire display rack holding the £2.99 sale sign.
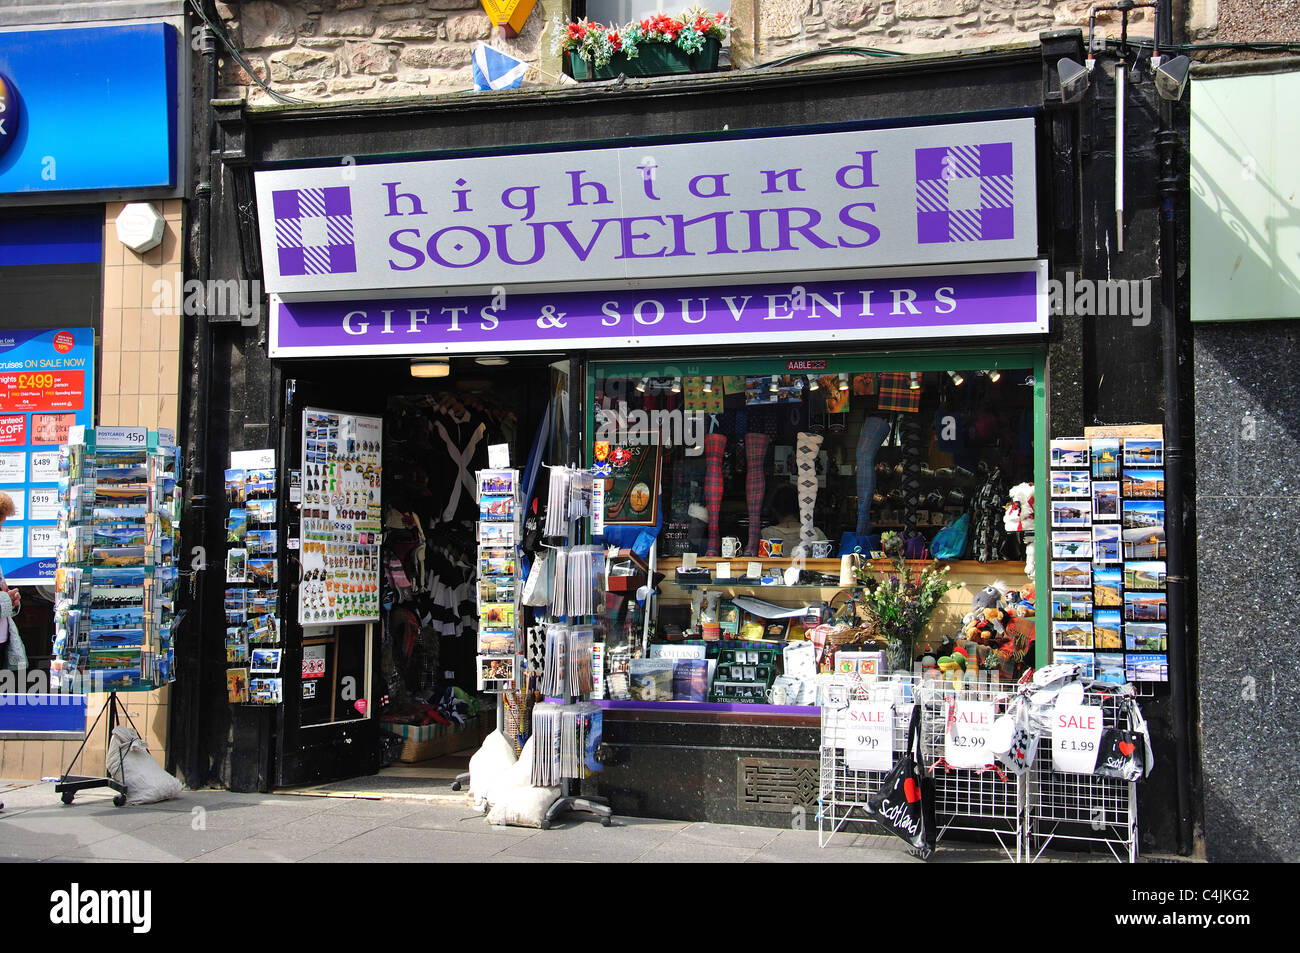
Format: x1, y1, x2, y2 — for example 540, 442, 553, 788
919, 681, 1027, 863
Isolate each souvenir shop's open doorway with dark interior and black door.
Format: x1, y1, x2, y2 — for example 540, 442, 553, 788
276, 356, 567, 793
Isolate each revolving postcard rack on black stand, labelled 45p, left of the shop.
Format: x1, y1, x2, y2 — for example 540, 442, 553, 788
51, 426, 181, 807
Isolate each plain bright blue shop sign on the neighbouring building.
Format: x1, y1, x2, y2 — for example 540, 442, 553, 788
0, 23, 178, 195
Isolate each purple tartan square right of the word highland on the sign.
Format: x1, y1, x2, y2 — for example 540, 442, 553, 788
917, 142, 1015, 244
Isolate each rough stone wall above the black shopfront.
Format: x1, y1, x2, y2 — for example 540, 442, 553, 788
217, 0, 1170, 103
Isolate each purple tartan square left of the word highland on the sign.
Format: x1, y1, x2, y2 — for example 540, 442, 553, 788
272, 186, 356, 276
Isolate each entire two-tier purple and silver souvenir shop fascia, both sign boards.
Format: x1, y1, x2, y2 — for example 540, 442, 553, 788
256, 120, 1047, 356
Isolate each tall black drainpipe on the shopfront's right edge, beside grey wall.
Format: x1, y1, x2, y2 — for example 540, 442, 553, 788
1156, 0, 1192, 855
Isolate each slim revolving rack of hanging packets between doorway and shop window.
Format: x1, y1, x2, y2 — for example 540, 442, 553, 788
532, 467, 614, 829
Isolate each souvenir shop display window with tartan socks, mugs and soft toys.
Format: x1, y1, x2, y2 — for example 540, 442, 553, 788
588, 347, 1047, 714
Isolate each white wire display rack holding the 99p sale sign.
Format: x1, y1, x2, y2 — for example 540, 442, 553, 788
818, 675, 917, 848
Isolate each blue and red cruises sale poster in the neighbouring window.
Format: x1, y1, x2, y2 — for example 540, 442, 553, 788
0, 328, 95, 585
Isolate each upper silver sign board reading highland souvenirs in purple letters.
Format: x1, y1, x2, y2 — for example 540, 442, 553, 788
256, 120, 1037, 299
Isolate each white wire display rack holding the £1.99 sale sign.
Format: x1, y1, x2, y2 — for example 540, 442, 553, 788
1024, 696, 1138, 863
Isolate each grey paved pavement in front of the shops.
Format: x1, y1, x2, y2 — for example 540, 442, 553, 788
0, 780, 1034, 863
